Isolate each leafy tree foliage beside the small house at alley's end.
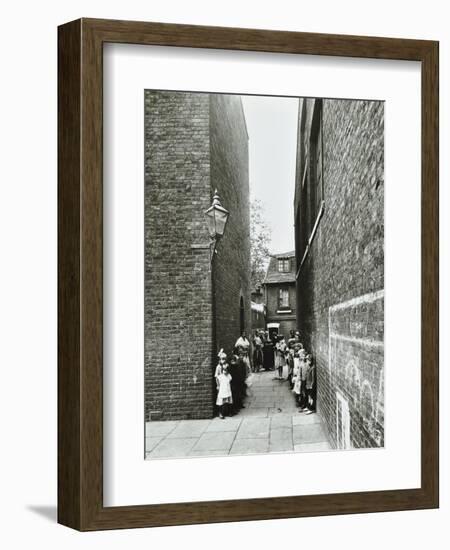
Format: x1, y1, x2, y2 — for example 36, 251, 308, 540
250, 199, 271, 294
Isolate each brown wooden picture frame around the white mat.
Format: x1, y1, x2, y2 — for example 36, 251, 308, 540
58, 19, 439, 531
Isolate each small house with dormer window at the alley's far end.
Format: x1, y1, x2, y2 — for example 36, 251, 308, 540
263, 251, 297, 339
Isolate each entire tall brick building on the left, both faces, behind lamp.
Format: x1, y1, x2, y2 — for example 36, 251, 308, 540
144, 90, 251, 420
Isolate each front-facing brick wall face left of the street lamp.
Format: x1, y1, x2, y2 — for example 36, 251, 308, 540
145, 91, 213, 419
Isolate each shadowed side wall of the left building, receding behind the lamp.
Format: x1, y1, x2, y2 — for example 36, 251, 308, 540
210, 95, 252, 353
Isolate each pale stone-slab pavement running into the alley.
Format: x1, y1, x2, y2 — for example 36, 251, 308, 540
145, 371, 331, 459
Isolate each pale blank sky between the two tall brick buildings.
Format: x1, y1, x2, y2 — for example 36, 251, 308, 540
242, 96, 298, 254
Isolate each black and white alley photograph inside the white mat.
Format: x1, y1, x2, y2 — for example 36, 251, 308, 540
143, 90, 385, 460
